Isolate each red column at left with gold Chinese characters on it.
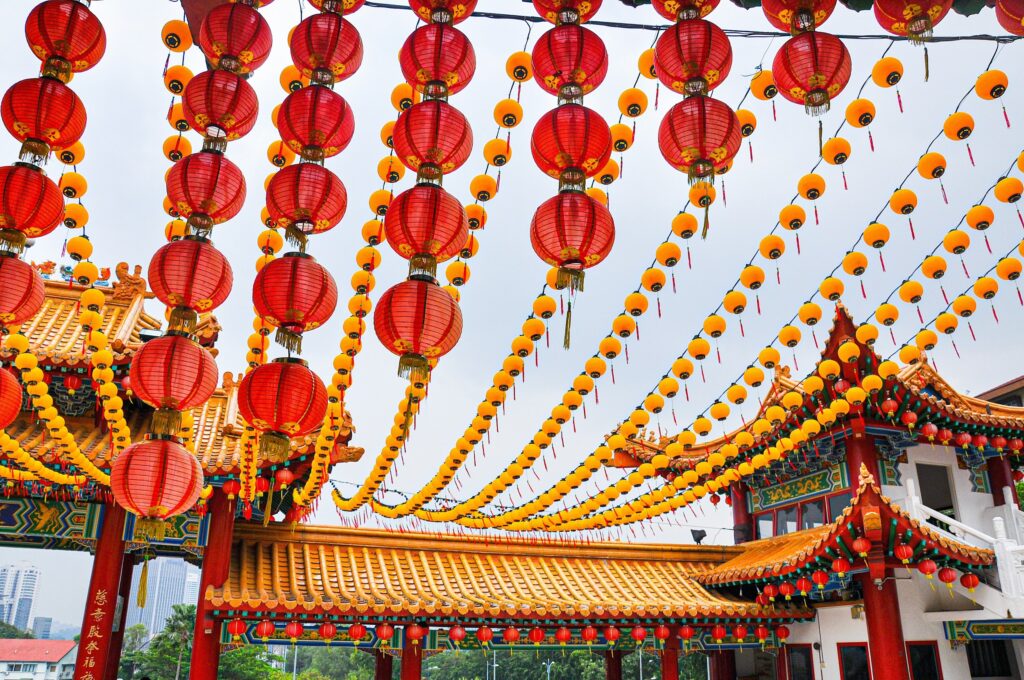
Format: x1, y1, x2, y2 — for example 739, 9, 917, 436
75, 504, 125, 680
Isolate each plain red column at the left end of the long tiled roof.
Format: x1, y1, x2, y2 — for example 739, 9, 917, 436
188, 490, 234, 680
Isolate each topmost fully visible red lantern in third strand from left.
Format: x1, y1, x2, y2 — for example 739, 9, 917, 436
291, 12, 362, 85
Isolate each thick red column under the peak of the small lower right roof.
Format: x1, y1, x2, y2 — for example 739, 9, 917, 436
857, 569, 910, 680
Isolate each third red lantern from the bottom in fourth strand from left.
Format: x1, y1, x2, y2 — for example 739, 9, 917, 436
391, 99, 473, 179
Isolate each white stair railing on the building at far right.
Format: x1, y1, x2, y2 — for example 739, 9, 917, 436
904, 479, 1024, 615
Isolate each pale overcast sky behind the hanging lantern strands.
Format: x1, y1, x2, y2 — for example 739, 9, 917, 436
0, 0, 1024, 623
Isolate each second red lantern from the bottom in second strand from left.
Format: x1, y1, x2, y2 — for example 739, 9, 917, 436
128, 331, 218, 434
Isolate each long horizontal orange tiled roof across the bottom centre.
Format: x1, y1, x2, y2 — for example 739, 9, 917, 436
206, 525, 806, 621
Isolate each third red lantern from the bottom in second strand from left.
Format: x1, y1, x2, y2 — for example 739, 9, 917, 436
148, 236, 234, 331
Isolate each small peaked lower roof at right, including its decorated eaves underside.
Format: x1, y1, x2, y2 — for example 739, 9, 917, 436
697, 467, 994, 585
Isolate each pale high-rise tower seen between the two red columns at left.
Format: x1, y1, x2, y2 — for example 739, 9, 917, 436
127, 557, 199, 638
